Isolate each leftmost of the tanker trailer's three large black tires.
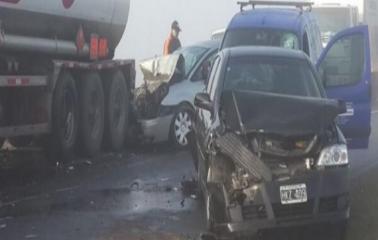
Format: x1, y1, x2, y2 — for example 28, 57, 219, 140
49, 72, 79, 160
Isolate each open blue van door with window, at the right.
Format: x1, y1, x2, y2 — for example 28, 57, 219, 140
317, 26, 371, 149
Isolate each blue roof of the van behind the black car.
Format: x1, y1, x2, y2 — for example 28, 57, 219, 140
228, 8, 309, 32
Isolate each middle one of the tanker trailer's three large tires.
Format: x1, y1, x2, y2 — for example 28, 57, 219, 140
79, 72, 105, 157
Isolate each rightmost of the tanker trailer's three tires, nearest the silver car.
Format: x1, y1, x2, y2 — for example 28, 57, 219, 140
104, 71, 130, 151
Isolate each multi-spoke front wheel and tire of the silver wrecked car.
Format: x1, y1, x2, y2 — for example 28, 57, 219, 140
169, 104, 194, 149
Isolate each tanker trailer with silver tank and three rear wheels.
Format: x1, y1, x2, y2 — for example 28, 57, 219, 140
0, 0, 135, 159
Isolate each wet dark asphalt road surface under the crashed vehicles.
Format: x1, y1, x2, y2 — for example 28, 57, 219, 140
0, 114, 378, 240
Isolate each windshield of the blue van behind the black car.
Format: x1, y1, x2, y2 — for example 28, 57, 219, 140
222, 29, 299, 49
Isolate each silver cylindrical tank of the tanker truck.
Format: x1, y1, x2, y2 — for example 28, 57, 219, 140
0, 0, 130, 58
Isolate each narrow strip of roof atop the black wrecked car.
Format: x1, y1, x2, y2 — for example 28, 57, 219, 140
222, 46, 308, 60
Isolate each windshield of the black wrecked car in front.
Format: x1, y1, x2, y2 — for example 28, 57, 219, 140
224, 57, 321, 97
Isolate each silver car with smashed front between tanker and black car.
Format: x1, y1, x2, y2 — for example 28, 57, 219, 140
135, 41, 220, 148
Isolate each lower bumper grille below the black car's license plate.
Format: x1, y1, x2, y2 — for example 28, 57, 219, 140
273, 200, 314, 218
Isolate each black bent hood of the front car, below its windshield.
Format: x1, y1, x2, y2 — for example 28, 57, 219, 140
222, 91, 340, 136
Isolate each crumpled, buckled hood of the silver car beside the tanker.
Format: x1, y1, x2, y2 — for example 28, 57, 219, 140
139, 54, 185, 84
